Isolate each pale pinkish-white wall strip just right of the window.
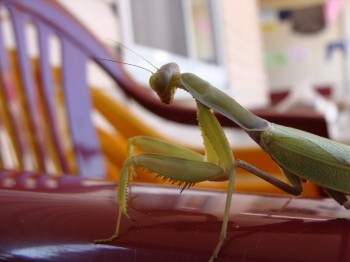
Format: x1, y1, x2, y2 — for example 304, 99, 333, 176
221, 0, 269, 108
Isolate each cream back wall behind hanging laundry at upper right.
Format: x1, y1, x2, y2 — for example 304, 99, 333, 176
262, 0, 346, 100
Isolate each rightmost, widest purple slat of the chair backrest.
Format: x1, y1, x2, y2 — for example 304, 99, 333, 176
61, 38, 103, 177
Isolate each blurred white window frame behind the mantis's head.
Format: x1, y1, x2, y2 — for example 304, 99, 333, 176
116, 0, 229, 98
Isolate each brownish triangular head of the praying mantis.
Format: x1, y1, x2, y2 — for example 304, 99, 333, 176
149, 63, 180, 104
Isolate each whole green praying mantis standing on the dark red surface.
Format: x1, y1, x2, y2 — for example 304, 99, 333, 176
95, 59, 350, 261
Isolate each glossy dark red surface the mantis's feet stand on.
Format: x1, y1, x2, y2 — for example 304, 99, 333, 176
0, 172, 350, 261
